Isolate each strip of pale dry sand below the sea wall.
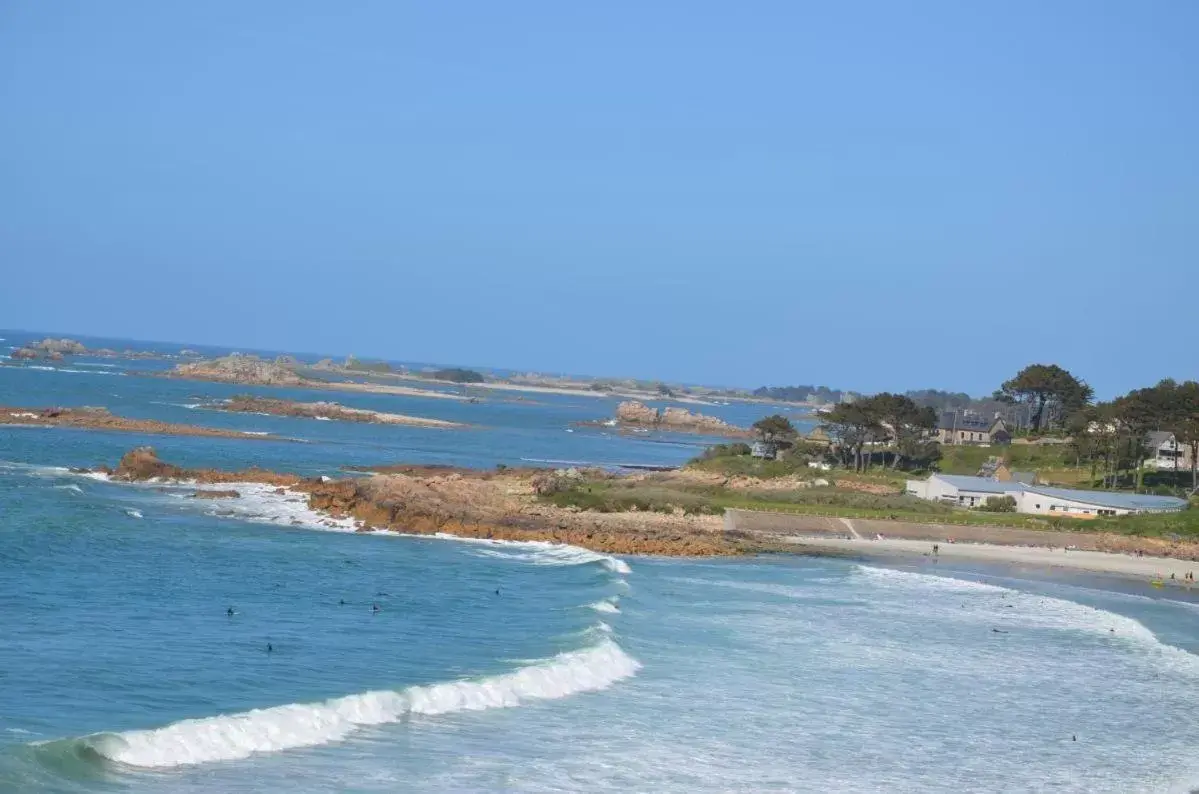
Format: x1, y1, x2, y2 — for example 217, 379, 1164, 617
779, 535, 1199, 585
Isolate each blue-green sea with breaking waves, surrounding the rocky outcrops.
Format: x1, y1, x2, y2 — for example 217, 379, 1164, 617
0, 332, 1199, 792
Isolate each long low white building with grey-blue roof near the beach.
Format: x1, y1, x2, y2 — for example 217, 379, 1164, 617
908, 474, 1187, 518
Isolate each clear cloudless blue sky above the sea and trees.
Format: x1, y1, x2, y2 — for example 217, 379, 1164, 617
0, 0, 1199, 396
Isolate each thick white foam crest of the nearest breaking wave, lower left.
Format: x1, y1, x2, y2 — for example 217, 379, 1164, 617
84, 639, 640, 768
